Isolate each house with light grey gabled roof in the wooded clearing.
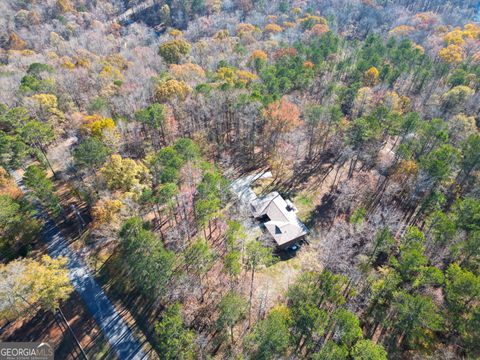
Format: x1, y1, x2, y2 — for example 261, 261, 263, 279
250, 191, 308, 248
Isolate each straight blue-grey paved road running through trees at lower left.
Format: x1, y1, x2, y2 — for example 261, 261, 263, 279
13, 172, 145, 360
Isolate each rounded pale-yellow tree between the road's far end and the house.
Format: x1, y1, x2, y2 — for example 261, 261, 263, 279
100, 154, 150, 192
